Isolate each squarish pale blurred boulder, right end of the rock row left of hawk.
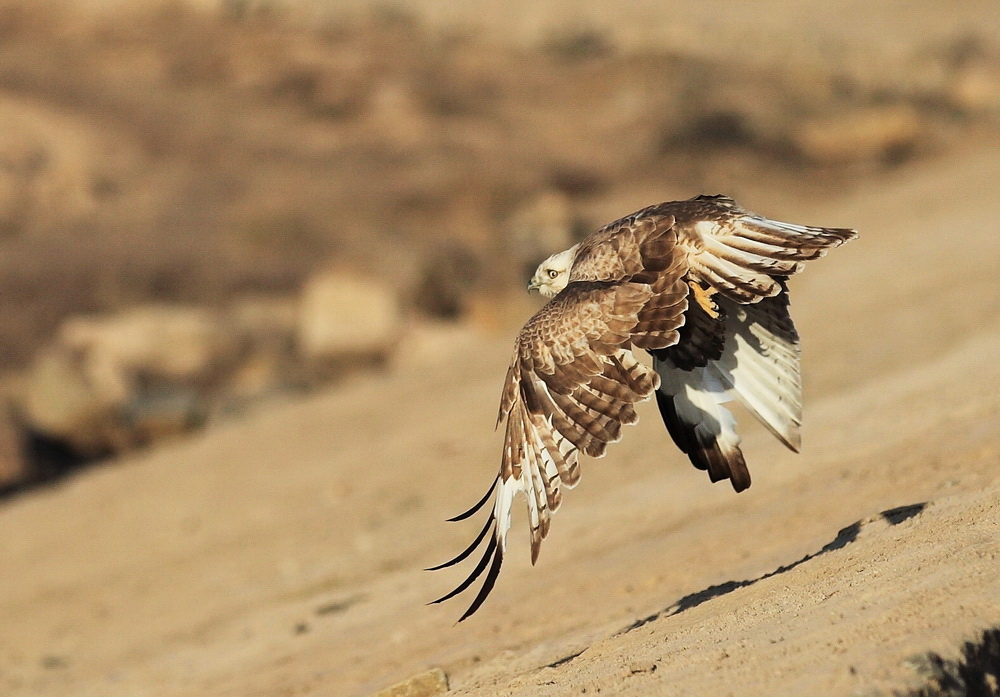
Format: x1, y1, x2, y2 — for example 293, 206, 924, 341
296, 270, 402, 371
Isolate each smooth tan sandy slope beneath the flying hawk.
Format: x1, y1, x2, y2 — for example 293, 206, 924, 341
0, 144, 1000, 696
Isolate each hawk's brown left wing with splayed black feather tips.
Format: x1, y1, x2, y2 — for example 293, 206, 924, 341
434, 274, 687, 621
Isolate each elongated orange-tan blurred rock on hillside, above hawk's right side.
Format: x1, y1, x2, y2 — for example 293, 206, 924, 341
791, 105, 924, 165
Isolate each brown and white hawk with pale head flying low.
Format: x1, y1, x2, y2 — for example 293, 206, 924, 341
432, 196, 857, 621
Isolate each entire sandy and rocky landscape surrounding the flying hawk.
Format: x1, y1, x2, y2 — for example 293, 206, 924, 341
0, 0, 1000, 697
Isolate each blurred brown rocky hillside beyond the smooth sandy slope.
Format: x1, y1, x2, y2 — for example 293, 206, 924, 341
0, 0, 1000, 494
